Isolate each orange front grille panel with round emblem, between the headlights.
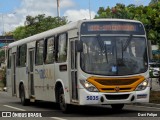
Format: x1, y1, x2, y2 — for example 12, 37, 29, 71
87, 76, 145, 93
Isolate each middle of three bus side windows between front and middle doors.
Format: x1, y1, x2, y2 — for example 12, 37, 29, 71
45, 37, 55, 64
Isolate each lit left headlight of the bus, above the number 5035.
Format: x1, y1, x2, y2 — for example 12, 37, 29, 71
80, 80, 98, 92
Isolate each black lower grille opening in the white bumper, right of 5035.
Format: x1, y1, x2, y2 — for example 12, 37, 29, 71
105, 94, 129, 100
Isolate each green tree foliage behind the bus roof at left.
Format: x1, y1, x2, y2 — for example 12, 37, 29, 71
13, 14, 67, 40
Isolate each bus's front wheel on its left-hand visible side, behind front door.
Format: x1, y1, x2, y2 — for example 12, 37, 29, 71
59, 88, 71, 113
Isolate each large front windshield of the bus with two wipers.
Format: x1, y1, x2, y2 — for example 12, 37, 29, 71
81, 35, 148, 76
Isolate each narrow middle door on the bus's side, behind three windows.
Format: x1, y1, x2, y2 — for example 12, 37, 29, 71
28, 49, 35, 102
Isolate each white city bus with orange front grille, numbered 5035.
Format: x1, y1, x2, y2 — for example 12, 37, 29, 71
7, 19, 150, 113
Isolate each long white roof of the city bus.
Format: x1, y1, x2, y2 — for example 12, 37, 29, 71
8, 19, 141, 48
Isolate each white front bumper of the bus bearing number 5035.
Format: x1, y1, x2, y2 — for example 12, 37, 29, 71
79, 87, 150, 105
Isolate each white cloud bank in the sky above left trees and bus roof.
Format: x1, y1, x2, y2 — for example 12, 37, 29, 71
0, 0, 96, 32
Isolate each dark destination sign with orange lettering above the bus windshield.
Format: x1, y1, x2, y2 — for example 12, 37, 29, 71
81, 21, 145, 35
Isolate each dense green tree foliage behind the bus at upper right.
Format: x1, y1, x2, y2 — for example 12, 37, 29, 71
95, 0, 160, 48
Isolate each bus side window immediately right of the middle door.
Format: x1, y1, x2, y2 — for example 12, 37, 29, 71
35, 40, 44, 65
